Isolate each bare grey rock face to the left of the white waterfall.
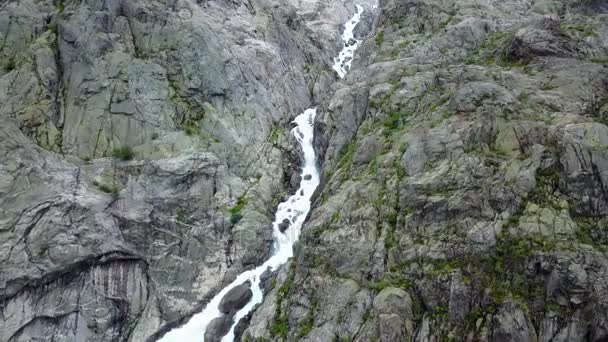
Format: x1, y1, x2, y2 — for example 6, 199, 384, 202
0, 0, 366, 341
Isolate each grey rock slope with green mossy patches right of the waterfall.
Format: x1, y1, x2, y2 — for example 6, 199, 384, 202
244, 0, 608, 341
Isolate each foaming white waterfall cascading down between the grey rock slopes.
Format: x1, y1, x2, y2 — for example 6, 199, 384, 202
158, 5, 363, 342
